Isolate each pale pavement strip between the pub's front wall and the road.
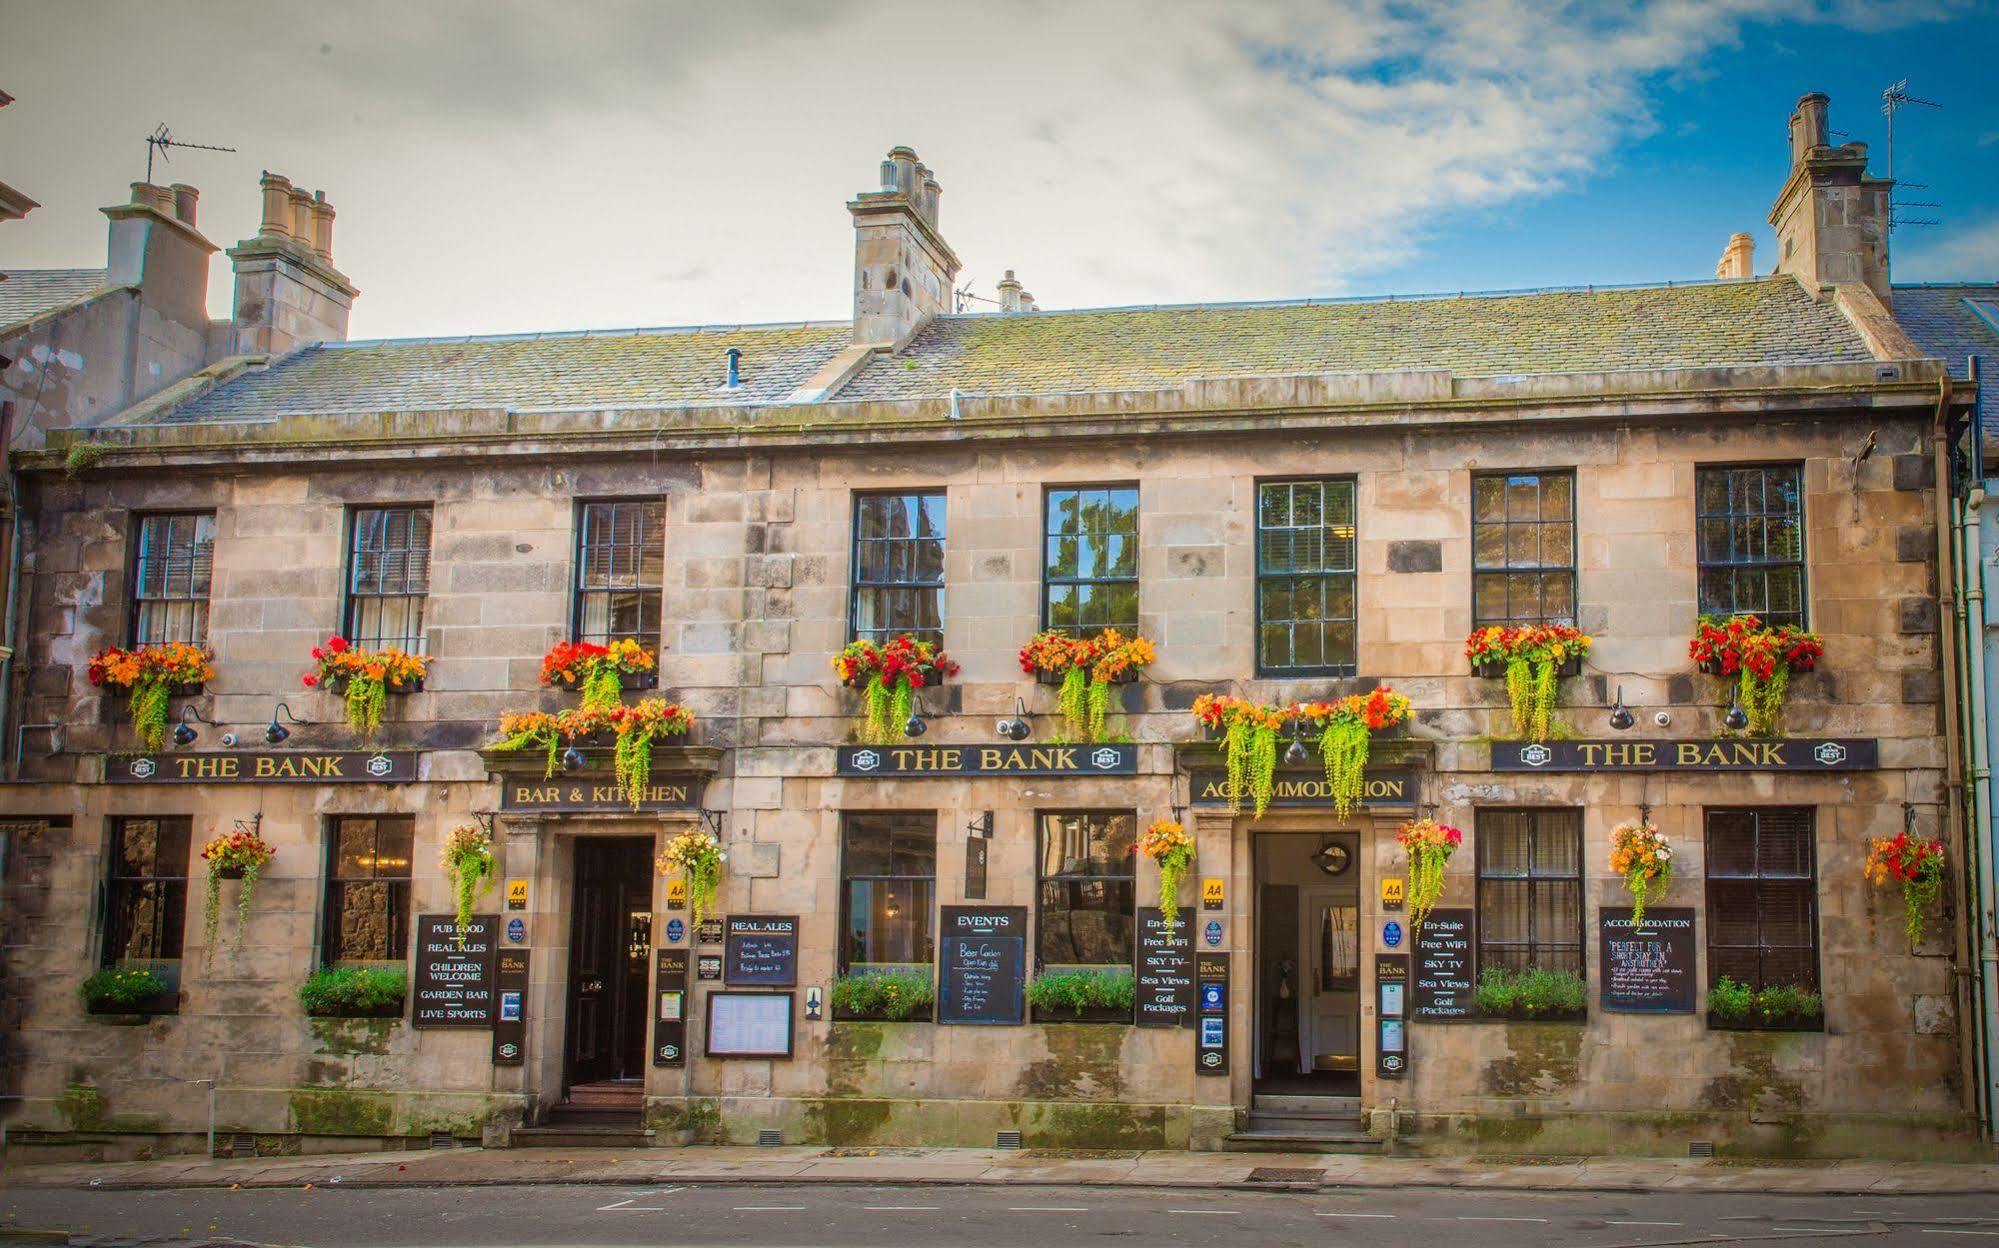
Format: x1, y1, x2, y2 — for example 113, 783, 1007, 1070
0, 1146, 1999, 1196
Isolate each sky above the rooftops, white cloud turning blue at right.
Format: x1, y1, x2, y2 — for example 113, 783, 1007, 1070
0, 0, 1999, 336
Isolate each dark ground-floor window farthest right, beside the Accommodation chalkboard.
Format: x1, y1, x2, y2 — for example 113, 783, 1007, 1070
1707, 806, 1819, 992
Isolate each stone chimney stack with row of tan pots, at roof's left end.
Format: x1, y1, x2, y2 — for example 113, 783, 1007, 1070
230, 170, 358, 356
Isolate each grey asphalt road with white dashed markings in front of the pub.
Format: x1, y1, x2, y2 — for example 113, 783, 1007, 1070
0, 1184, 1999, 1248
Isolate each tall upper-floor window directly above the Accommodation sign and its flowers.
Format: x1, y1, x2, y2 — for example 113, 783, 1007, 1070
1255, 480, 1355, 676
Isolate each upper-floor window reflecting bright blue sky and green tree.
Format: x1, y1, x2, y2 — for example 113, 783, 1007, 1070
1041, 486, 1137, 636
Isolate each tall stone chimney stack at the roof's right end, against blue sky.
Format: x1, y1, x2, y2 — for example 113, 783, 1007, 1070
1769, 92, 1895, 304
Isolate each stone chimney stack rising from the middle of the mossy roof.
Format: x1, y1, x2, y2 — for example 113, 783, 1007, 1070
848, 148, 958, 348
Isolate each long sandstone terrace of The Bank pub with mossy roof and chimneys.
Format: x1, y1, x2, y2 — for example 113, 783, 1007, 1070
0, 96, 1999, 1158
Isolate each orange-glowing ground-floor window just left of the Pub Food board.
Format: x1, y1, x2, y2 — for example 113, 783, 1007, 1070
320, 814, 416, 962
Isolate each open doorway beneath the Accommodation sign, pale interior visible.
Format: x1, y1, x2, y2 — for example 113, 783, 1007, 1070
1253, 832, 1361, 1096
